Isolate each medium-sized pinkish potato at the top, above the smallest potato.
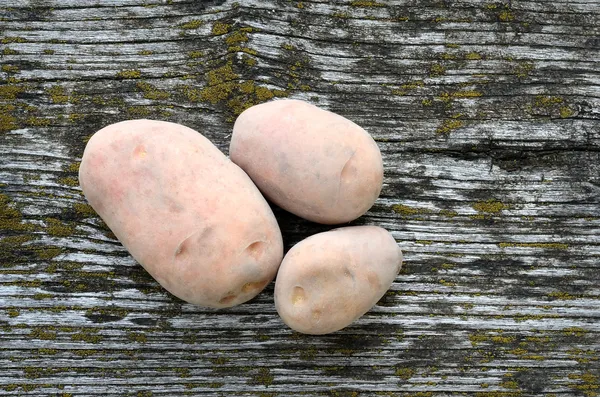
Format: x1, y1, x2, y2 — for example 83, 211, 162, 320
229, 100, 383, 224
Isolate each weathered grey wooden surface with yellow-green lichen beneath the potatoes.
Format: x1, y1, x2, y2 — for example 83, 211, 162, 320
0, 0, 600, 397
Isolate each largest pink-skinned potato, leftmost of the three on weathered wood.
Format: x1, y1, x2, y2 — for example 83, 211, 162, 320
79, 120, 283, 308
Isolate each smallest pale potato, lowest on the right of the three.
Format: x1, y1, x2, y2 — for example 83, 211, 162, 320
275, 226, 402, 335
